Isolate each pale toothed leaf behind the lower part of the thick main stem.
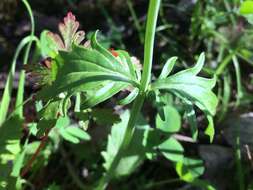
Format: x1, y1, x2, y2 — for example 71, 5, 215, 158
102, 111, 149, 177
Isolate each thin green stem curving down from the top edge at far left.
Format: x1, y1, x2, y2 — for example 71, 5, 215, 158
16, 0, 35, 117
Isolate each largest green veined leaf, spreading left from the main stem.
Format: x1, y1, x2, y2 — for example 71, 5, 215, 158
37, 30, 139, 109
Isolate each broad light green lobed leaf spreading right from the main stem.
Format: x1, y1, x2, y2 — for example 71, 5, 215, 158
152, 54, 218, 115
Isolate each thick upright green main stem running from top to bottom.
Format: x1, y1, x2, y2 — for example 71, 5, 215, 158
96, 0, 161, 190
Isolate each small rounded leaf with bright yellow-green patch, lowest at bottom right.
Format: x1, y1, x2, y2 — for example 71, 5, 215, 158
176, 157, 204, 182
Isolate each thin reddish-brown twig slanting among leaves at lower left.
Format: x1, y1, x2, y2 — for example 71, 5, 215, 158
21, 128, 52, 177
